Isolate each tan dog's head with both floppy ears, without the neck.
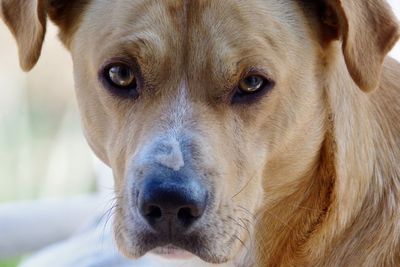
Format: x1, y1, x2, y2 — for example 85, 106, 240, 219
1, 0, 398, 263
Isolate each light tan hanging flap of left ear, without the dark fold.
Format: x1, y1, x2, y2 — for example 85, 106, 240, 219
0, 0, 46, 71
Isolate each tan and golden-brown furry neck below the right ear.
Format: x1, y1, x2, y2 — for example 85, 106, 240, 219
255, 45, 400, 266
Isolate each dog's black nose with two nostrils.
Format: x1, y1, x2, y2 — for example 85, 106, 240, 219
139, 176, 208, 233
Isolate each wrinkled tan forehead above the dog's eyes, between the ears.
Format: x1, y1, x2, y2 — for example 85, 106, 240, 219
76, 0, 301, 84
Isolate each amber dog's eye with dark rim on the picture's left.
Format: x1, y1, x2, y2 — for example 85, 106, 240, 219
102, 63, 138, 97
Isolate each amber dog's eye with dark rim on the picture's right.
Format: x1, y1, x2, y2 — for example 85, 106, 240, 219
232, 75, 275, 103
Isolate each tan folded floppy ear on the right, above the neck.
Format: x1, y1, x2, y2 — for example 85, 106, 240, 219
320, 0, 400, 91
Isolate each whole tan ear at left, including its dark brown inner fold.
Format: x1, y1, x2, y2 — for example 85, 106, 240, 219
0, 0, 90, 71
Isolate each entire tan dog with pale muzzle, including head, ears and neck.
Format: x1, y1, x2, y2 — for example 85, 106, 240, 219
0, 0, 400, 267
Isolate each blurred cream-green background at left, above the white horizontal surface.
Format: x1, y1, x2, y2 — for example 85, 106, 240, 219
0, 17, 94, 202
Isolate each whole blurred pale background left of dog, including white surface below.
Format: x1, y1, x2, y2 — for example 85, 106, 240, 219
0, 13, 108, 267
